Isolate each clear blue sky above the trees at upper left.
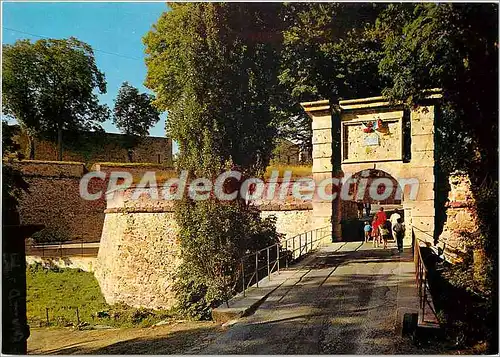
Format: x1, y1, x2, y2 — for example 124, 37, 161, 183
2, 2, 167, 136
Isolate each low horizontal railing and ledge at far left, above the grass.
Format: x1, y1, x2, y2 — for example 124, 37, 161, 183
26, 241, 99, 258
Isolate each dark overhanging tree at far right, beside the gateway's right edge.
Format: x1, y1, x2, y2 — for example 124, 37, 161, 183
377, 4, 498, 180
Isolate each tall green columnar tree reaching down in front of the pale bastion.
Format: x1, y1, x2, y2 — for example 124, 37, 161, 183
144, 3, 281, 317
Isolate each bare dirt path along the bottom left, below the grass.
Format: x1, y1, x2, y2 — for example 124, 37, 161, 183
28, 322, 221, 355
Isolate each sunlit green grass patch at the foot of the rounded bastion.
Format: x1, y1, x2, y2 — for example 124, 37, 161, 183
26, 264, 173, 327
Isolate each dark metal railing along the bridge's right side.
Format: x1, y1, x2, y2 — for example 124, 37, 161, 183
413, 234, 439, 325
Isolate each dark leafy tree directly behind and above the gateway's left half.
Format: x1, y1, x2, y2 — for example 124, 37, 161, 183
279, 3, 386, 154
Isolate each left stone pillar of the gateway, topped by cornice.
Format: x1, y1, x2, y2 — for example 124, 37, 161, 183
301, 100, 335, 243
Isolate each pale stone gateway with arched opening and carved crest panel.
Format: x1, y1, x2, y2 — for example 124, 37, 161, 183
302, 91, 441, 244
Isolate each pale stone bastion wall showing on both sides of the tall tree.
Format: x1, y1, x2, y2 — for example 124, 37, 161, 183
94, 181, 312, 308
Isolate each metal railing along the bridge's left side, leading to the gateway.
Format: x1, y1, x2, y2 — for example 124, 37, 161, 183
238, 227, 331, 296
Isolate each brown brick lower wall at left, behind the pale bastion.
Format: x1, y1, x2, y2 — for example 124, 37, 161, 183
6, 160, 177, 242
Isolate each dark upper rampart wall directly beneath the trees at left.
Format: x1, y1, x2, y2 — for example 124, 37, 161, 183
4, 125, 172, 164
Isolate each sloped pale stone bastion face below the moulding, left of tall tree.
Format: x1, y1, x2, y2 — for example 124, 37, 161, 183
94, 212, 181, 309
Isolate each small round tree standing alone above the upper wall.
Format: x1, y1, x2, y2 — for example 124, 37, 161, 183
113, 82, 160, 136
